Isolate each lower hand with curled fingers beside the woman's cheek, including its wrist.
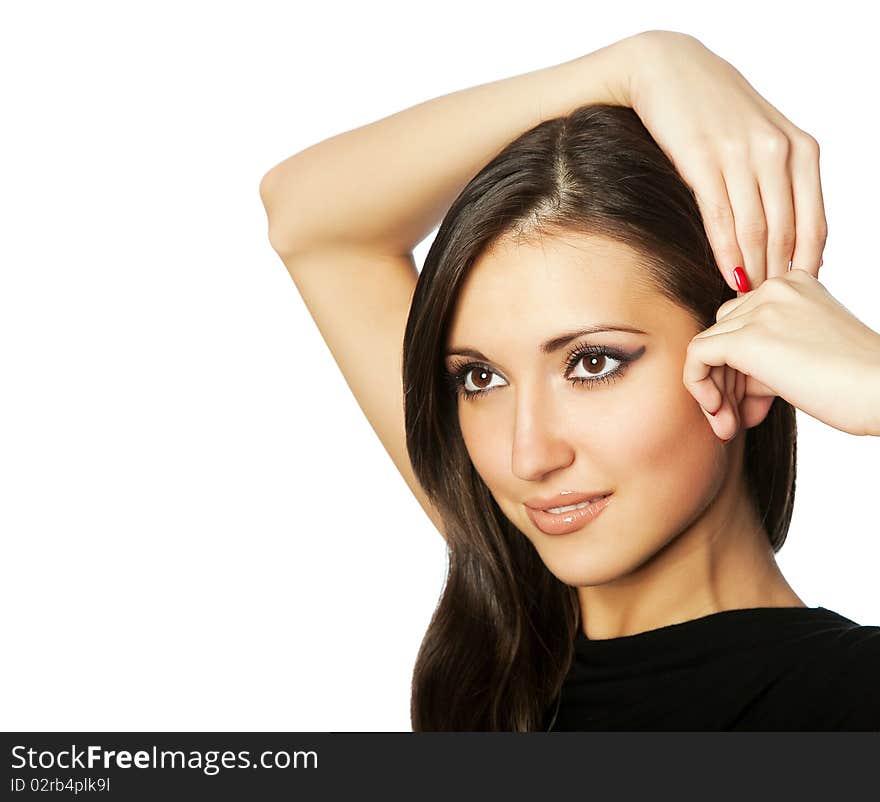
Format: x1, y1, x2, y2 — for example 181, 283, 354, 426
683, 268, 880, 441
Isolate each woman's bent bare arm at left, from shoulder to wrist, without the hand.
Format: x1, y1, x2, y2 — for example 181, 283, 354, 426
260, 34, 643, 536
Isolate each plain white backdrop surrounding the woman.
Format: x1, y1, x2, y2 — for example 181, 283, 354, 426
0, 0, 880, 731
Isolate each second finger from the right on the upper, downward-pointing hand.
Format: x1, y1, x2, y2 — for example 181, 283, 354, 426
758, 141, 795, 278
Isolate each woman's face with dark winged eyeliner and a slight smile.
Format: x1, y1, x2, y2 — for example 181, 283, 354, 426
446, 228, 728, 586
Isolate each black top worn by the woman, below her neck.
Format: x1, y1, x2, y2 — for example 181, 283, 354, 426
545, 607, 880, 732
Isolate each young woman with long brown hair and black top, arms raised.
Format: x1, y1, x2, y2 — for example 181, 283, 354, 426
261, 31, 880, 731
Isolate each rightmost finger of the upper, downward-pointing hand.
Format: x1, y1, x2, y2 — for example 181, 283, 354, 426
791, 131, 828, 278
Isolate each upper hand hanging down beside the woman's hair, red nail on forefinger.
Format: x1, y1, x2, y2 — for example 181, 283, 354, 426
628, 31, 828, 290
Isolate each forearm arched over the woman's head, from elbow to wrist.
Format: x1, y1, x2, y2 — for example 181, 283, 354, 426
260, 34, 644, 258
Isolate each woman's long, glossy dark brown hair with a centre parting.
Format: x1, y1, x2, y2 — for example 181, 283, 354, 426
403, 105, 797, 731
